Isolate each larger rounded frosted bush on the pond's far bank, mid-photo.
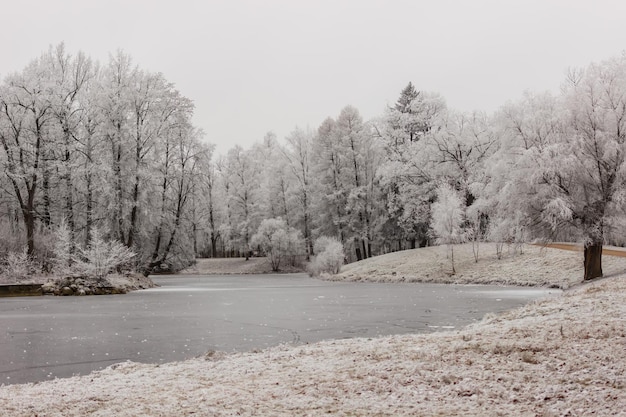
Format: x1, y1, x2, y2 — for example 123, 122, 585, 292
250, 218, 303, 271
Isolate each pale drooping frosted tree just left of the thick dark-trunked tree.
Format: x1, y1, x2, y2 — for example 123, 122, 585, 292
470, 93, 556, 257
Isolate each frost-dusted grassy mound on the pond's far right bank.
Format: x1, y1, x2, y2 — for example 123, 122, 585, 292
325, 243, 626, 289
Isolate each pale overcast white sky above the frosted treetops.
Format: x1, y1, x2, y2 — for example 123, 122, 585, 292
0, 0, 626, 152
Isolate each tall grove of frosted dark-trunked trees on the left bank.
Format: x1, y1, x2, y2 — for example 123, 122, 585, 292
0, 45, 211, 271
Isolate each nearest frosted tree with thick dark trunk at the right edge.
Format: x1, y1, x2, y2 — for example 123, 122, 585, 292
552, 54, 626, 279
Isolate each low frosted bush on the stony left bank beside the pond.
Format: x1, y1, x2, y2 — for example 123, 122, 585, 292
72, 229, 135, 279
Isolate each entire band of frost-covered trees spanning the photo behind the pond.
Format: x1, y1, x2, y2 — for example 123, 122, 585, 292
0, 45, 626, 278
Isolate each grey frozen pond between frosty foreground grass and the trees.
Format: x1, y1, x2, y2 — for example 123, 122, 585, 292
0, 274, 559, 384
